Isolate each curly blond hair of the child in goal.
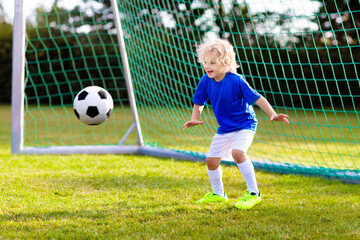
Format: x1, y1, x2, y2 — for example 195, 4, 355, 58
196, 38, 239, 73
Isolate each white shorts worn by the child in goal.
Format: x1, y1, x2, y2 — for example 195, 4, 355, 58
207, 129, 255, 160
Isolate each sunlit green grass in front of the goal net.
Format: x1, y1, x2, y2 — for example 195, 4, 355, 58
0, 106, 360, 240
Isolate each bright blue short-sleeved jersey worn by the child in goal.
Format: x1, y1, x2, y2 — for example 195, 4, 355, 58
193, 72, 261, 134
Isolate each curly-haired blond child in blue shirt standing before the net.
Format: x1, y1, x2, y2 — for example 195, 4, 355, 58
183, 39, 289, 209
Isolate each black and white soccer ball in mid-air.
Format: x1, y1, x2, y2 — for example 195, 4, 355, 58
74, 86, 114, 125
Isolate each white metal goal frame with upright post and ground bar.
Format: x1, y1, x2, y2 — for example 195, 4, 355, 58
11, 0, 201, 161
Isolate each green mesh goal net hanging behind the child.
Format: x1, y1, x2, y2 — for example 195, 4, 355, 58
12, 0, 360, 183
